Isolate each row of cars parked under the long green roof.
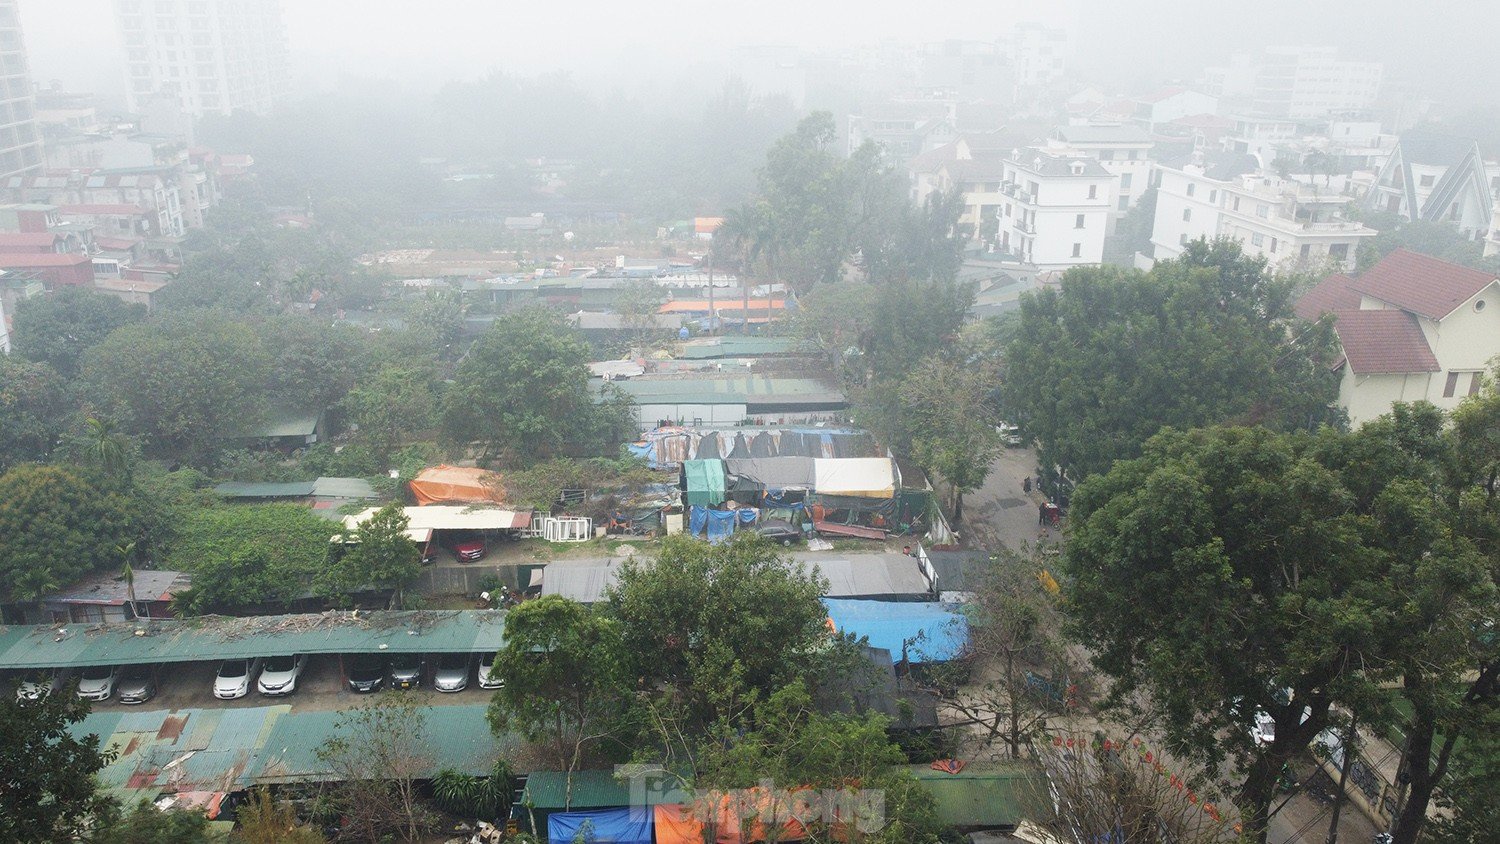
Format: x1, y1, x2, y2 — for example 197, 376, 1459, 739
17, 654, 504, 703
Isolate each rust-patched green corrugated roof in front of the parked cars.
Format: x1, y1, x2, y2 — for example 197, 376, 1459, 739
71, 703, 504, 801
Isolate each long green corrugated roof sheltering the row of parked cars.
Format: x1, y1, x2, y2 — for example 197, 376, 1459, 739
0, 610, 506, 669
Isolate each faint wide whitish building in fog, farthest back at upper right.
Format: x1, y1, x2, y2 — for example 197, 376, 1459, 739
1203, 46, 1385, 118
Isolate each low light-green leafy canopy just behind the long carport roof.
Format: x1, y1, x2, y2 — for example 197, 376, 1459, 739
167, 504, 336, 613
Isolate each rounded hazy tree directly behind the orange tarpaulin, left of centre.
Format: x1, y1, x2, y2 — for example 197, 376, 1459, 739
443, 309, 626, 465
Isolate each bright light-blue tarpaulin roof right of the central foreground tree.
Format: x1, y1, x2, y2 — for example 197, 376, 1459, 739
824, 598, 969, 663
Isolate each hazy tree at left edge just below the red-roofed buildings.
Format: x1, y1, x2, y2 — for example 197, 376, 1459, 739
12, 286, 146, 378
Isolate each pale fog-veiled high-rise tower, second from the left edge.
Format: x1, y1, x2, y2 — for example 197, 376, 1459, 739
116, 0, 288, 117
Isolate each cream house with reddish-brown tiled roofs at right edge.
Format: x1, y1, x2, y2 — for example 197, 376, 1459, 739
1298, 249, 1500, 424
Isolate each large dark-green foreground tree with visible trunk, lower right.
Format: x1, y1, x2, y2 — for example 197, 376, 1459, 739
1065, 429, 1458, 841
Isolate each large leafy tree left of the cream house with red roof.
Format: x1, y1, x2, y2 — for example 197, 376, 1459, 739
1002, 240, 1338, 480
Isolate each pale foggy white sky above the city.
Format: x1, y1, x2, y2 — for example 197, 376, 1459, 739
11, 0, 1500, 110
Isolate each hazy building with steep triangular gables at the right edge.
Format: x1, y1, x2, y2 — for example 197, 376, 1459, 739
1365, 132, 1496, 240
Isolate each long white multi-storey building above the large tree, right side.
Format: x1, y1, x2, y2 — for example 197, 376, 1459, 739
1151, 153, 1377, 270
